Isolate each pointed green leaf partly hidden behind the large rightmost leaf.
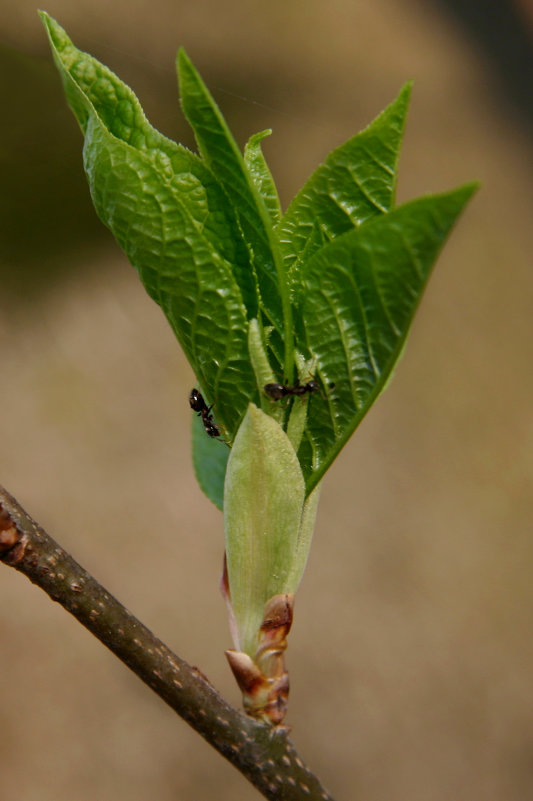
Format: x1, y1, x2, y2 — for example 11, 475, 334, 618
277, 83, 411, 290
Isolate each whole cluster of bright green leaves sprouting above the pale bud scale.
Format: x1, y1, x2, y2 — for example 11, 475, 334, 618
41, 12, 475, 536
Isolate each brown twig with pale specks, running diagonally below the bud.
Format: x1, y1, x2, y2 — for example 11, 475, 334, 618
0, 486, 333, 801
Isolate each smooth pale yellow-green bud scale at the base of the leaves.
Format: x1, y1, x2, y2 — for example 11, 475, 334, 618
224, 404, 306, 657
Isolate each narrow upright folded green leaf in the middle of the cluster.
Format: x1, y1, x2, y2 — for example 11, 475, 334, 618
178, 48, 293, 375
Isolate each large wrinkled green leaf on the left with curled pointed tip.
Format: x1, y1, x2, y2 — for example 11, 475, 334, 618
41, 13, 257, 440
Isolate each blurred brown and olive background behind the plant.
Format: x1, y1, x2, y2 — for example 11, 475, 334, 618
0, 0, 533, 801
